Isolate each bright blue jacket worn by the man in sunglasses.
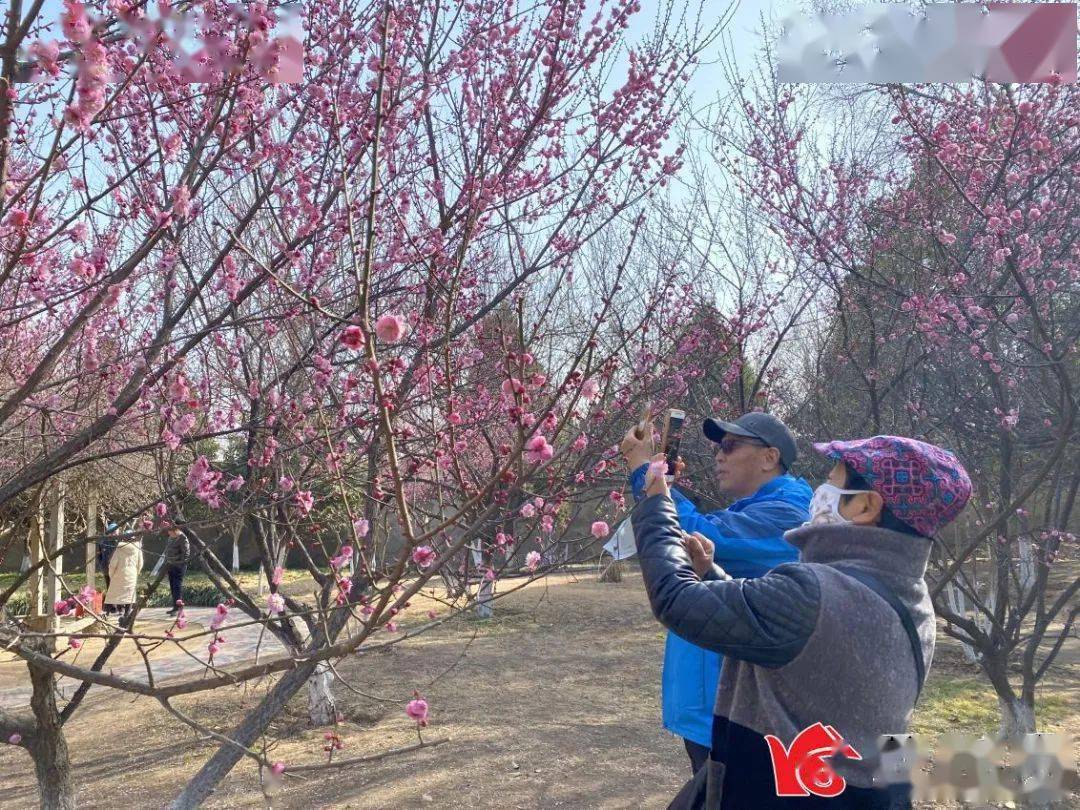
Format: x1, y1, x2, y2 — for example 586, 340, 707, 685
630, 464, 813, 747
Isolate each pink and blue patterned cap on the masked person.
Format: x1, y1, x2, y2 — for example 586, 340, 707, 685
813, 436, 971, 537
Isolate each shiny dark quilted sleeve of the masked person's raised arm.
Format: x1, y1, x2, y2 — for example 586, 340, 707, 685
631, 495, 821, 667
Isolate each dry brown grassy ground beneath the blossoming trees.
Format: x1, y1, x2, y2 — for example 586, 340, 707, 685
0, 572, 1080, 810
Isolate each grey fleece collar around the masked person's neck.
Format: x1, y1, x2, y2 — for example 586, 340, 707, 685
784, 524, 930, 579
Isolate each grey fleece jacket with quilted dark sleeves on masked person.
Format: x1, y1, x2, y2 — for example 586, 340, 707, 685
632, 496, 935, 809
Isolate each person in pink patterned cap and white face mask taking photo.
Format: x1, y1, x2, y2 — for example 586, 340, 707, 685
632, 436, 971, 810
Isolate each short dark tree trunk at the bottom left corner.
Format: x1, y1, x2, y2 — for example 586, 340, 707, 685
27, 644, 76, 810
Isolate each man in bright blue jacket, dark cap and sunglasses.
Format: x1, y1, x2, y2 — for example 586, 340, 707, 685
621, 414, 811, 772
